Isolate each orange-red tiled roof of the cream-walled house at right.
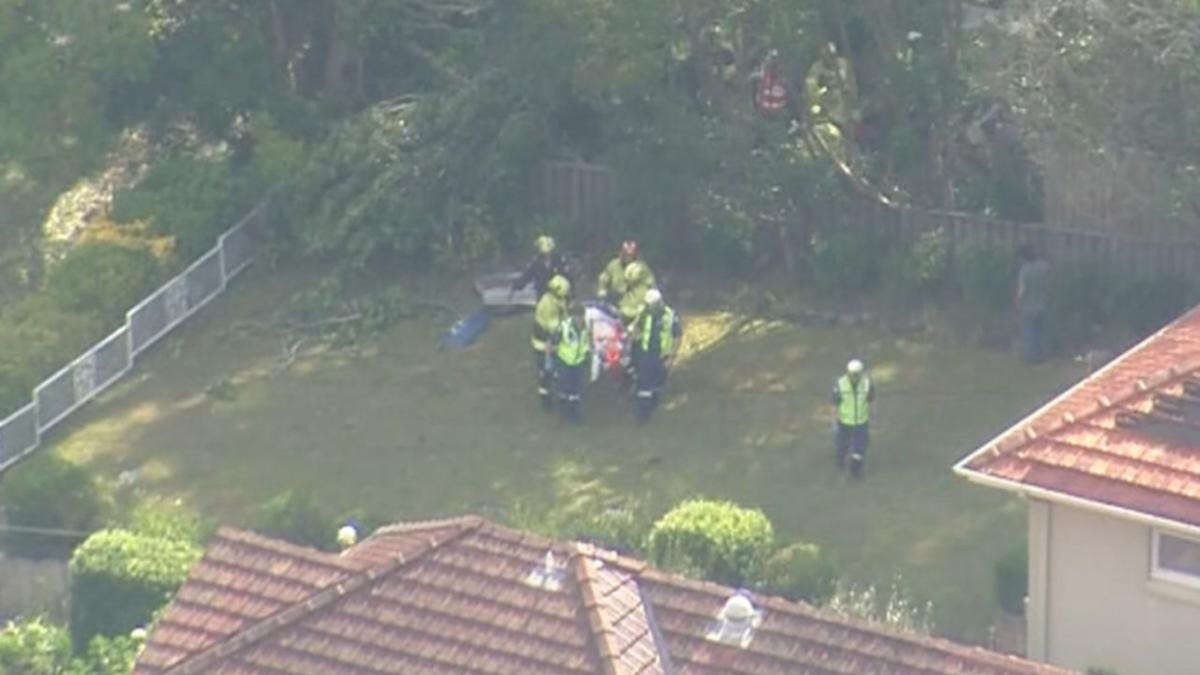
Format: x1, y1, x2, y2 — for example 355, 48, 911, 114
955, 302, 1200, 526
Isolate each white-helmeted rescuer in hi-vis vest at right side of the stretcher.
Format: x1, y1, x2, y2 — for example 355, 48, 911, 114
634, 288, 683, 424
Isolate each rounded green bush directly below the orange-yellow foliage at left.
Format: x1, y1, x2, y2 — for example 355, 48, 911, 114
47, 241, 160, 325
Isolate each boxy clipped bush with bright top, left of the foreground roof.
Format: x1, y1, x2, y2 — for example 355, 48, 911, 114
70, 530, 202, 652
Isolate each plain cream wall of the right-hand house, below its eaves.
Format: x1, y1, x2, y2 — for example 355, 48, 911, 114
1030, 502, 1200, 675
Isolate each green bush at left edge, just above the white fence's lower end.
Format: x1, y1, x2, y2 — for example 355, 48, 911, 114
0, 294, 103, 418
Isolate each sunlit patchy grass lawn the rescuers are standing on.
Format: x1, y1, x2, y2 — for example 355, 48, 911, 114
44, 261, 1080, 641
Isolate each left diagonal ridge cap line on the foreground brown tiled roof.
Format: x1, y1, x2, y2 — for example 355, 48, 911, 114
164, 524, 453, 675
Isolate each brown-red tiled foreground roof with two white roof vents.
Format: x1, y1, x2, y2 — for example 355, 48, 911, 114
134, 516, 1066, 675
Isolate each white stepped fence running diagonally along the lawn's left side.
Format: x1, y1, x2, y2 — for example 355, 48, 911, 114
0, 202, 268, 474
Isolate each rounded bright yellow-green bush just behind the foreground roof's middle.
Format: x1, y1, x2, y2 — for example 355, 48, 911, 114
646, 500, 775, 586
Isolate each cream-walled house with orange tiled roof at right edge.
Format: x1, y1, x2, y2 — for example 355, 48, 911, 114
954, 307, 1200, 675
